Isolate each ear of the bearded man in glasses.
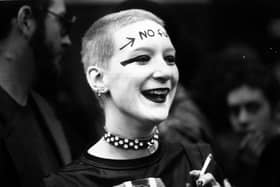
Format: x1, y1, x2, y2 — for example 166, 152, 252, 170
17, 5, 36, 40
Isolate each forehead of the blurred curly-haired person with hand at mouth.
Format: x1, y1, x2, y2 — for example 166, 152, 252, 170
227, 86, 265, 104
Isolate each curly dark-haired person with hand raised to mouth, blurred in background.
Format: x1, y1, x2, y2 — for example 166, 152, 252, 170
191, 47, 280, 186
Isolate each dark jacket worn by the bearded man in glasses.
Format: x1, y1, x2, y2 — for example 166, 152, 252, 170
0, 87, 71, 187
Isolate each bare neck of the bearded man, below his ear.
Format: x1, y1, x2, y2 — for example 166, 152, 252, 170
0, 39, 34, 105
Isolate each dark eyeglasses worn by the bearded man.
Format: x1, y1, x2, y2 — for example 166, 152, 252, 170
47, 10, 77, 36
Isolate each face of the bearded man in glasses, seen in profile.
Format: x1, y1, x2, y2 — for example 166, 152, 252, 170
33, 0, 71, 79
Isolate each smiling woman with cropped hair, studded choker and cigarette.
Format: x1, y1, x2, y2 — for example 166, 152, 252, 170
45, 9, 230, 187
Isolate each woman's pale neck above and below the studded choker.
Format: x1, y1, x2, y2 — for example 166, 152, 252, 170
88, 101, 159, 160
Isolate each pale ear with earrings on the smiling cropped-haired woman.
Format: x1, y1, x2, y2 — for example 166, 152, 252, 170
86, 66, 108, 93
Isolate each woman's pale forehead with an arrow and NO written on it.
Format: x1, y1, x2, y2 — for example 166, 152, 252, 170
113, 20, 173, 51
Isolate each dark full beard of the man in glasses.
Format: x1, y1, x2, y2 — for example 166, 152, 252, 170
31, 22, 61, 97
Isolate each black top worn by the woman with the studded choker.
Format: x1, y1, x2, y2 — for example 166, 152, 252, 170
45, 142, 223, 187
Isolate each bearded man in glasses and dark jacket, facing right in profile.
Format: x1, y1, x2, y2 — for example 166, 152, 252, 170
0, 0, 75, 187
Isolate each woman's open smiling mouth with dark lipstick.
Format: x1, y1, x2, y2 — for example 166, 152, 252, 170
141, 88, 170, 103
